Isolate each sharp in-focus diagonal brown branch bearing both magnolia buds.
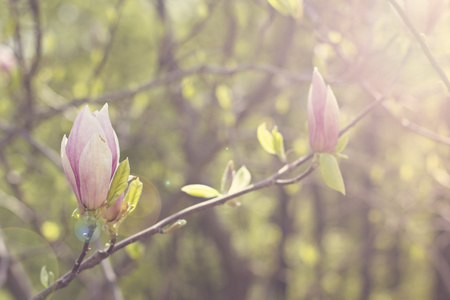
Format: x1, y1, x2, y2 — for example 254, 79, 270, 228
32, 88, 385, 300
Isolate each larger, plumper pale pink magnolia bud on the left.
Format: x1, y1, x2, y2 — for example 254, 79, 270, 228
61, 104, 119, 214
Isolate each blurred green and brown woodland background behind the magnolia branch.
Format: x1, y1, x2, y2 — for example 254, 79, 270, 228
0, 0, 450, 300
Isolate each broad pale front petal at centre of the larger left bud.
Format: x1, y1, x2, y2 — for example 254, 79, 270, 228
79, 133, 112, 210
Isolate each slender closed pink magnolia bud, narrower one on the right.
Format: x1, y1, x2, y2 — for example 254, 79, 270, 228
308, 68, 339, 152
